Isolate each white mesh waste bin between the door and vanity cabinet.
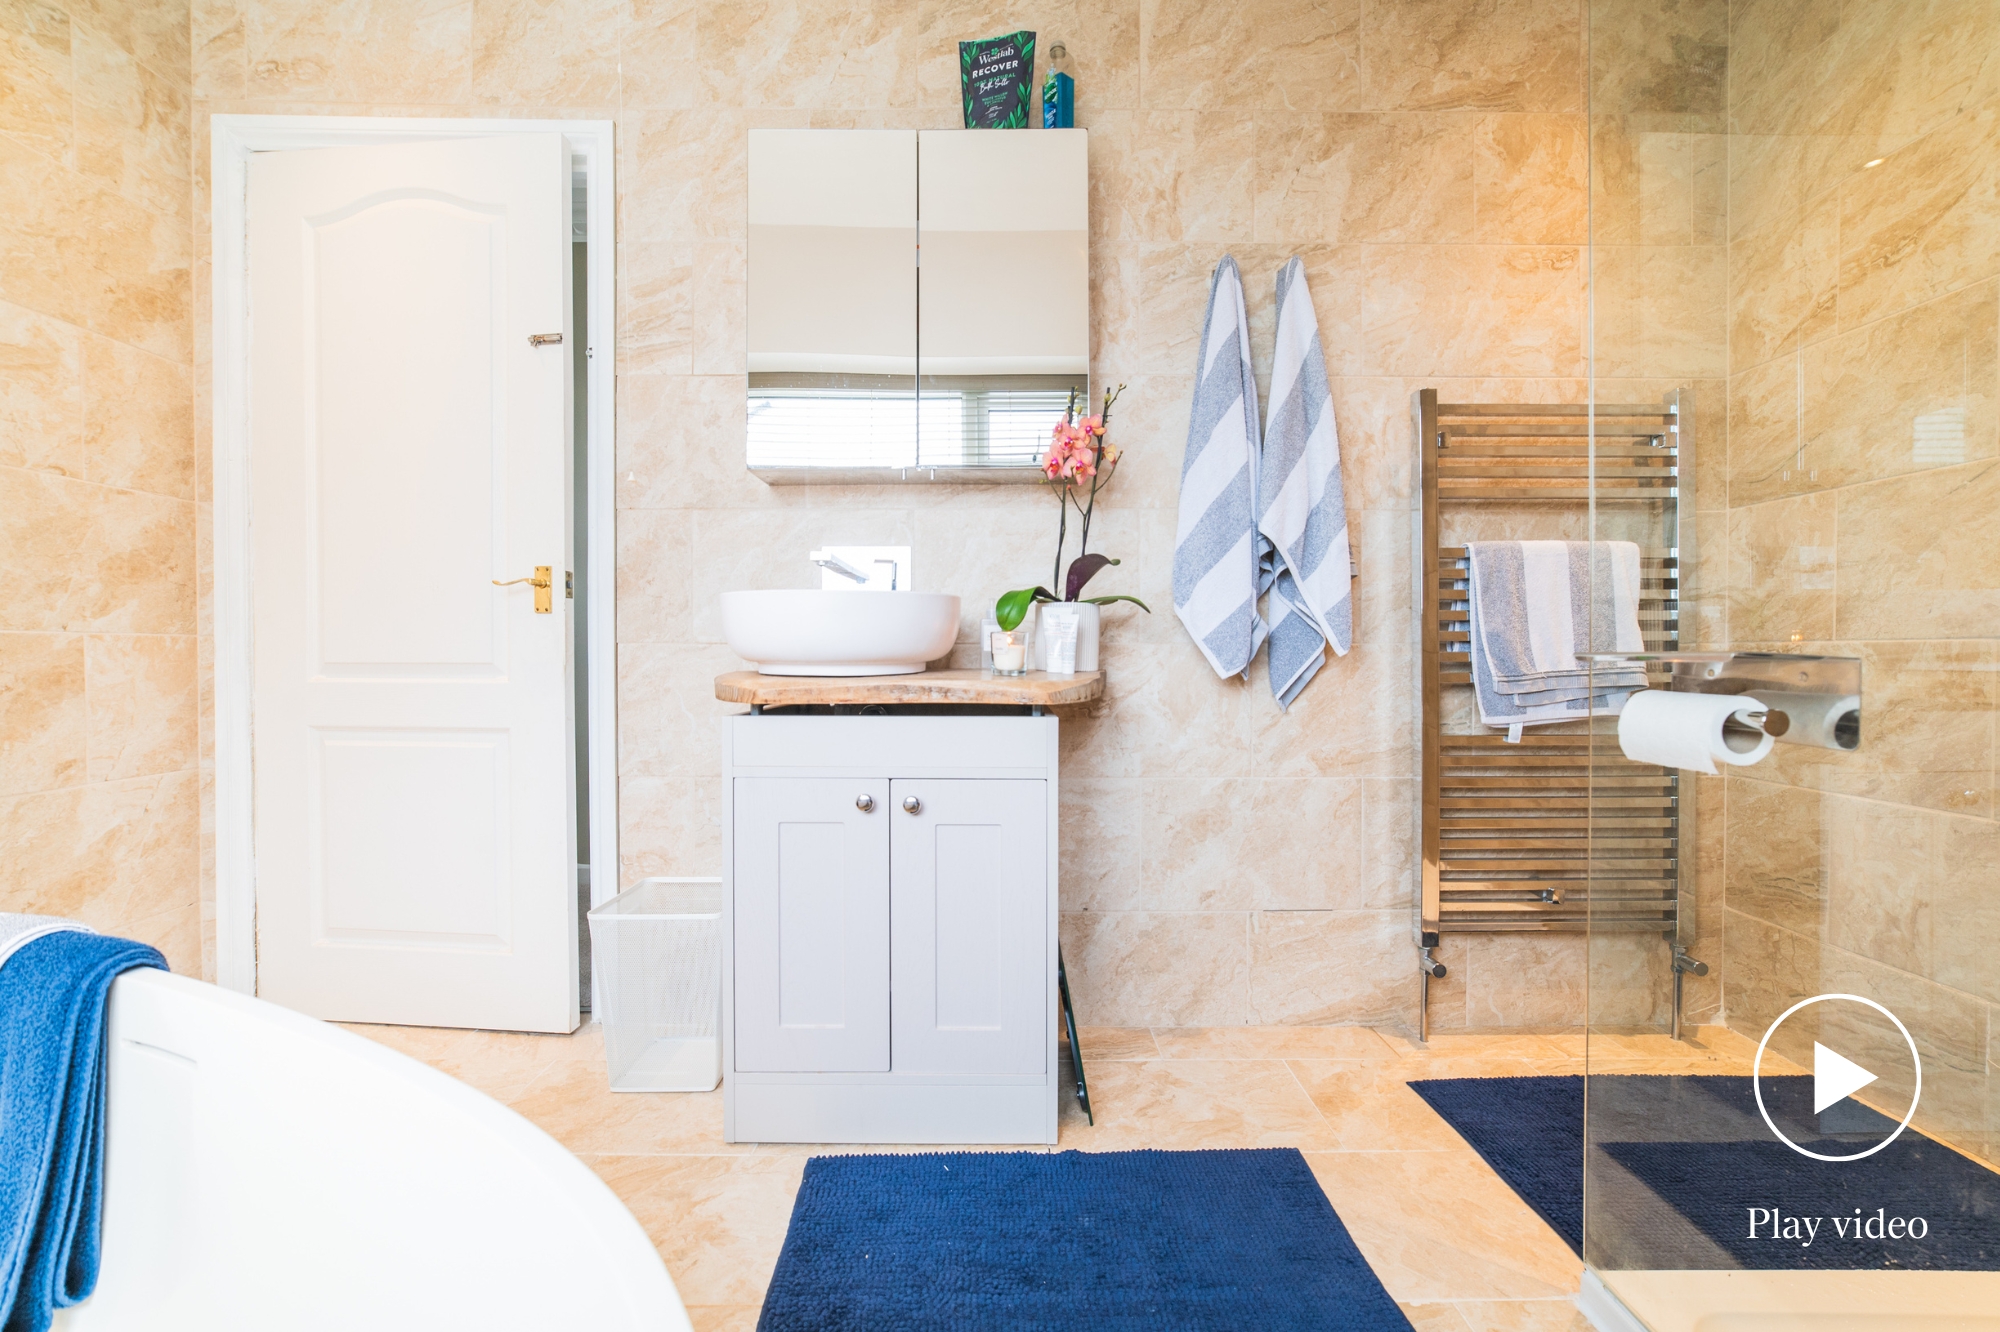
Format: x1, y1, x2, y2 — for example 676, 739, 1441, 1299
590, 878, 722, 1092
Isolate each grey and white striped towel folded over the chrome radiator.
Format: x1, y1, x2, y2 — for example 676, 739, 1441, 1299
1468, 542, 1646, 726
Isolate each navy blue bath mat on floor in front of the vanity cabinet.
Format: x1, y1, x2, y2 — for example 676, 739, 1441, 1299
758, 1150, 1410, 1332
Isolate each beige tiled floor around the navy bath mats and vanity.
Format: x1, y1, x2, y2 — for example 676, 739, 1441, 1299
352, 1026, 1784, 1332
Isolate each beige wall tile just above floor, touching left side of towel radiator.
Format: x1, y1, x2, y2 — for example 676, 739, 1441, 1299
1250, 910, 1416, 1026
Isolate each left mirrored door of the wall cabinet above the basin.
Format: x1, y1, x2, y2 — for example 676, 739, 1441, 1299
748, 130, 918, 478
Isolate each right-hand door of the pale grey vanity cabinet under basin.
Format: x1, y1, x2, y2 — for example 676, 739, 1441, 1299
890, 778, 1054, 1074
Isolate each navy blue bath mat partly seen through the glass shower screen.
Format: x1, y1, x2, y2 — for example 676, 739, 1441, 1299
1410, 1076, 2000, 1272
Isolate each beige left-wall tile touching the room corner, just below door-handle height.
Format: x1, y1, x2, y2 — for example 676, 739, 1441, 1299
84, 634, 198, 782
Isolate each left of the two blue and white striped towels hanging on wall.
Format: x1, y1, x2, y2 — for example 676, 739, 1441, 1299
1174, 254, 1268, 678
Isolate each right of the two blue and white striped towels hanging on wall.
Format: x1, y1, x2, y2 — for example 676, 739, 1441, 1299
1258, 256, 1354, 708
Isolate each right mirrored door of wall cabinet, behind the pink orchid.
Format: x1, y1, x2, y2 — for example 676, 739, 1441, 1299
916, 130, 1090, 470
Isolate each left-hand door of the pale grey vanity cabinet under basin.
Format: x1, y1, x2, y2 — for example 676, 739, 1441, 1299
732, 778, 892, 1072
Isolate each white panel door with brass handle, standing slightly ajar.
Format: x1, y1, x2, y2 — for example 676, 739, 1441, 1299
248, 134, 578, 1032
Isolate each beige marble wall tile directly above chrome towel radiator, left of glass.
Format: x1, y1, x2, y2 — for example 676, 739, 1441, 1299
1362, 246, 1586, 376
